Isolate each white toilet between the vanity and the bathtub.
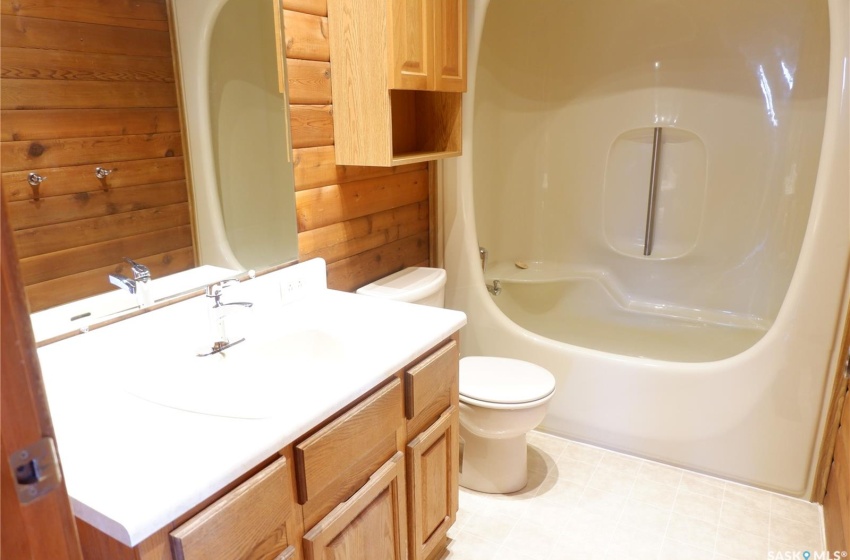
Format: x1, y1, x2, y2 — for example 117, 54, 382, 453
357, 267, 555, 494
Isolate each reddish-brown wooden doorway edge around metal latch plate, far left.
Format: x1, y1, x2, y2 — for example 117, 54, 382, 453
0, 199, 82, 560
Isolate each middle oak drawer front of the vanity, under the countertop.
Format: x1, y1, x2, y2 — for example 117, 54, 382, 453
295, 378, 403, 516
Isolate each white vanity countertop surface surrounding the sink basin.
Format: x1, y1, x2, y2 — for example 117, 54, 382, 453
39, 264, 466, 546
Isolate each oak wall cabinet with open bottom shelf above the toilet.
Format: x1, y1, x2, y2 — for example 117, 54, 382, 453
328, 0, 466, 166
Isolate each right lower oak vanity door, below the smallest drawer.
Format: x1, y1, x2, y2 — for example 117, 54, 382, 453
407, 407, 459, 560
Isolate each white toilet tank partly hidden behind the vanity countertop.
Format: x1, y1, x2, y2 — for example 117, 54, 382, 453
357, 266, 446, 307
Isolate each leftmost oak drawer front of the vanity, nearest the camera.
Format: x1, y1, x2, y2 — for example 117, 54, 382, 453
171, 458, 295, 560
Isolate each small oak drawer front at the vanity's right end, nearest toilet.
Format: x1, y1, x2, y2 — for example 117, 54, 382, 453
404, 340, 458, 436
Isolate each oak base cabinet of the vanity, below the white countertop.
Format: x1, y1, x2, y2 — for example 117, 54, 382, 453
76, 335, 459, 560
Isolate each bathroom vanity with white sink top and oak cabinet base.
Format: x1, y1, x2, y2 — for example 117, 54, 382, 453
39, 262, 466, 560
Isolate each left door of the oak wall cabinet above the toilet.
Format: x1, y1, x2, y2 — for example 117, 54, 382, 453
387, 0, 434, 90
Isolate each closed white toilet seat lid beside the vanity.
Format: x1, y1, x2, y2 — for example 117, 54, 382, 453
460, 356, 555, 408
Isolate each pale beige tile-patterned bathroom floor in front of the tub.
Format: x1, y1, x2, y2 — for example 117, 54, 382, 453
440, 433, 824, 560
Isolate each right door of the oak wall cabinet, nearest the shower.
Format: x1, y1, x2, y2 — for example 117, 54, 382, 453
434, 0, 466, 92
